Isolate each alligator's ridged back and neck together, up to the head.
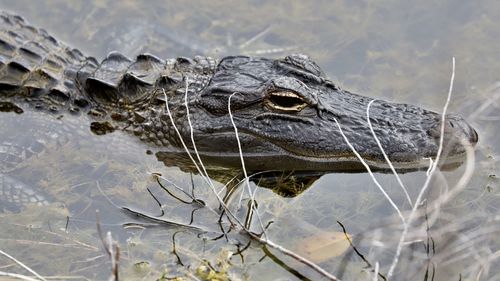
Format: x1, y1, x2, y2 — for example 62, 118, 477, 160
0, 12, 216, 125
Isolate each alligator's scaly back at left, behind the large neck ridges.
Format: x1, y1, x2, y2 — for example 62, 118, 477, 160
0, 12, 97, 111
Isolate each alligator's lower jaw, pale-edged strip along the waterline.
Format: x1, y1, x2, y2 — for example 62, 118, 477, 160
164, 126, 474, 173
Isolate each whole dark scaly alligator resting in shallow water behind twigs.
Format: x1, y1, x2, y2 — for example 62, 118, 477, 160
0, 12, 478, 207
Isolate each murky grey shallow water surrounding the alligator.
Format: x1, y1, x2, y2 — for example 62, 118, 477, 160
0, 0, 500, 280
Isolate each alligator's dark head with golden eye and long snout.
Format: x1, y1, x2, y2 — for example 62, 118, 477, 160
154, 52, 478, 172
